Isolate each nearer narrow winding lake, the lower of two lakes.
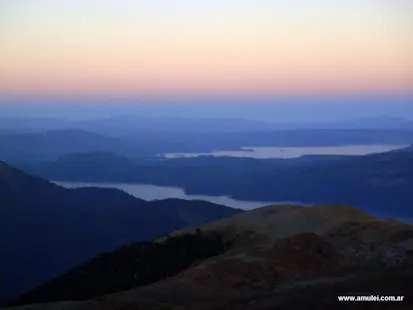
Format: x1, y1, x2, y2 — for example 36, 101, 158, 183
54, 182, 303, 210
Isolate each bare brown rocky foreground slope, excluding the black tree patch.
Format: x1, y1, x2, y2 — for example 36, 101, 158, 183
5, 205, 413, 310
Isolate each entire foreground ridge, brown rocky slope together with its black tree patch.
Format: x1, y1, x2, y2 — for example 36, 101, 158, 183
5, 205, 413, 310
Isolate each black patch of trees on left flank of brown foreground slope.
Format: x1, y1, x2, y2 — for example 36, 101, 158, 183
10, 230, 229, 305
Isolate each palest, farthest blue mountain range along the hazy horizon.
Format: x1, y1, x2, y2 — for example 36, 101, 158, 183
0, 115, 413, 135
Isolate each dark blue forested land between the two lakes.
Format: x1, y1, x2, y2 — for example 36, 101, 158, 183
16, 147, 413, 216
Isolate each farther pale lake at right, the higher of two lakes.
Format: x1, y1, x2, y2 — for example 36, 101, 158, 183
164, 145, 408, 159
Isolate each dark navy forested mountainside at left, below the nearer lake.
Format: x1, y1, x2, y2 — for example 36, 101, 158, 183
0, 162, 241, 302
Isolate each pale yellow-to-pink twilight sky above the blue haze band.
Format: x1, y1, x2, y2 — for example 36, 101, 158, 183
0, 0, 413, 101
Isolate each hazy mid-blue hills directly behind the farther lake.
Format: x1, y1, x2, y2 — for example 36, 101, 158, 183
0, 126, 413, 163
